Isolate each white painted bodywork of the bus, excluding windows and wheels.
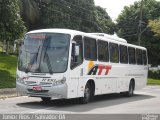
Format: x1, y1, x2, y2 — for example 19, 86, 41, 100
16, 29, 148, 99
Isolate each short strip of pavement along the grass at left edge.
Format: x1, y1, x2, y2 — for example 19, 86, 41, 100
0, 88, 18, 99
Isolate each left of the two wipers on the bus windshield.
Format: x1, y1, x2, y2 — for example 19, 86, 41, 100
25, 46, 40, 73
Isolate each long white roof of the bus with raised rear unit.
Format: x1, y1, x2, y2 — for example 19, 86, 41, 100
27, 28, 146, 50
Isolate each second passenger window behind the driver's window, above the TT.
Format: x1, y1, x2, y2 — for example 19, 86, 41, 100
98, 40, 109, 62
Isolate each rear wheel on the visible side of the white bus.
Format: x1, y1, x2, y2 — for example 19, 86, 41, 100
120, 81, 134, 97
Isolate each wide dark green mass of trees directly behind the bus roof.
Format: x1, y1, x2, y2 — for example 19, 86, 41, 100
19, 0, 114, 34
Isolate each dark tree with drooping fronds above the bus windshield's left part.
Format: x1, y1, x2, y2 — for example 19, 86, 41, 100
18, 0, 52, 31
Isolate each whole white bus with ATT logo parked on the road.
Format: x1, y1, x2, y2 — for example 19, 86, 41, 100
16, 29, 148, 103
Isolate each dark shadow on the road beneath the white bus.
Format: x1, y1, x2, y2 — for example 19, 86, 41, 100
17, 94, 154, 112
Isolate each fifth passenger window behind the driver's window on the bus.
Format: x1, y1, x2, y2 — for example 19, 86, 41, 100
128, 47, 136, 64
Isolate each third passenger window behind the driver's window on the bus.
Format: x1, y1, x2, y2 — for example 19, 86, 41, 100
109, 43, 119, 63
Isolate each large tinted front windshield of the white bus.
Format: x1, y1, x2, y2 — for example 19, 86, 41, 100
18, 33, 70, 73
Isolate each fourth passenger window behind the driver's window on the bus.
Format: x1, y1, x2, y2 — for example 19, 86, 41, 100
120, 45, 128, 63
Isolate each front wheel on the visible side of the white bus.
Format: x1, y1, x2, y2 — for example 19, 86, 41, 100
80, 83, 91, 104
